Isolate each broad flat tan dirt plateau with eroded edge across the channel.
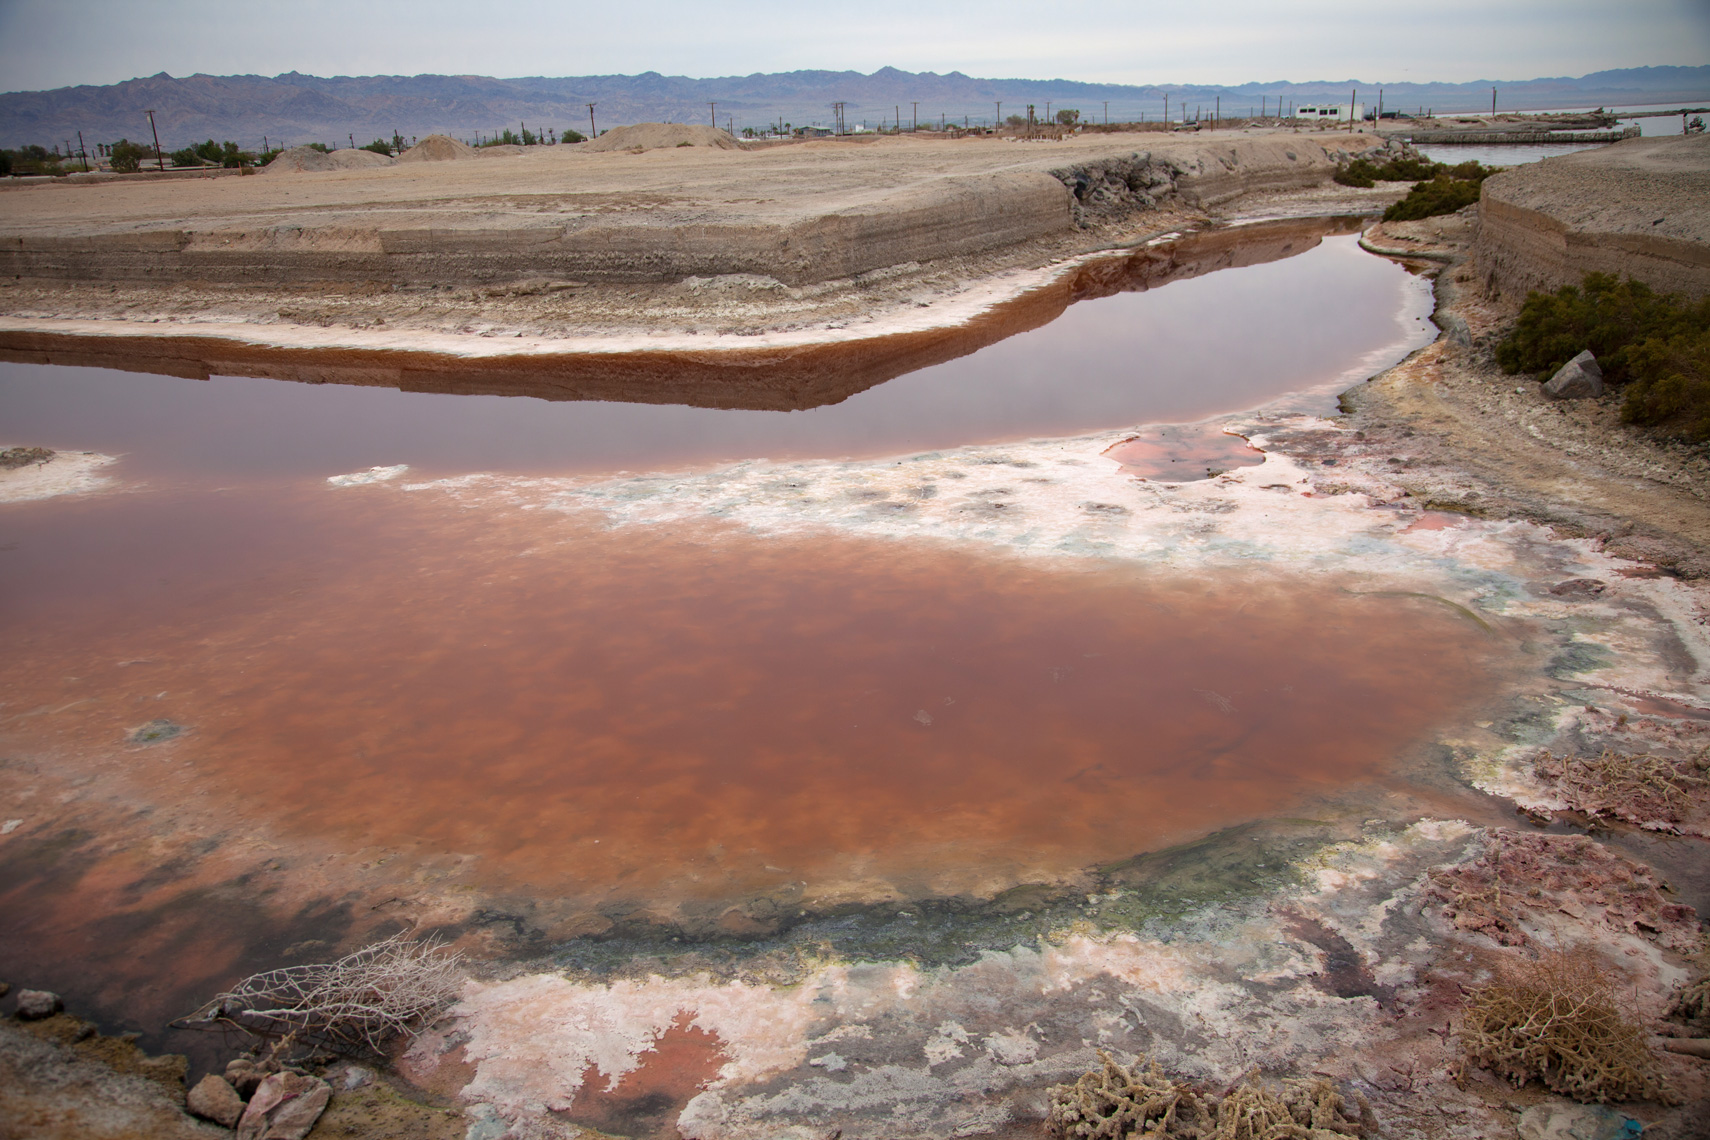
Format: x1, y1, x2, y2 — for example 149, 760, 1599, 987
0, 133, 1378, 287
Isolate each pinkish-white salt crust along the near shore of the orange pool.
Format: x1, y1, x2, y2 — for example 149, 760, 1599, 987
407, 820, 1481, 1140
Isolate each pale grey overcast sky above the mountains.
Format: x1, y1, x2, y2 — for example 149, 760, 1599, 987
0, 0, 1710, 91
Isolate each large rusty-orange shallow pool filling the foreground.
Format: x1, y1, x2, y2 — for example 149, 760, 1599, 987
0, 492, 1484, 902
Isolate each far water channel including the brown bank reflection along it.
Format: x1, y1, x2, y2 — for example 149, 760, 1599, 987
0, 219, 1435, 479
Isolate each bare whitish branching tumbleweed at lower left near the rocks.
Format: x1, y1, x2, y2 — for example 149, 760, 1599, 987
183, 933, 463, 1053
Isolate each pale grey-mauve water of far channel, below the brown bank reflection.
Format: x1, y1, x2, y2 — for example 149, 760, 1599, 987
0, 222, 1436, 480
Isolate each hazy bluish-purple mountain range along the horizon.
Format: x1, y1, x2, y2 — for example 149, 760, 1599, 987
0, 67, 1710, 150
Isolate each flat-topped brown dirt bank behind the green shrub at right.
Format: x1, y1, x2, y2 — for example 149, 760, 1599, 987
1474, 135, 1710, 297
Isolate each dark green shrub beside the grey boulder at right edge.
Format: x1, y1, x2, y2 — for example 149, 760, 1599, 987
1496, 273, 1710, 385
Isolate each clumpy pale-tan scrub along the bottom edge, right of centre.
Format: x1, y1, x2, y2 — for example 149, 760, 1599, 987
1047, 1049, 1377, 1140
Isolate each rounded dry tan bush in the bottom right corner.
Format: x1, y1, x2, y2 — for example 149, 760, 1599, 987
1459, 952, 1676, 1104
